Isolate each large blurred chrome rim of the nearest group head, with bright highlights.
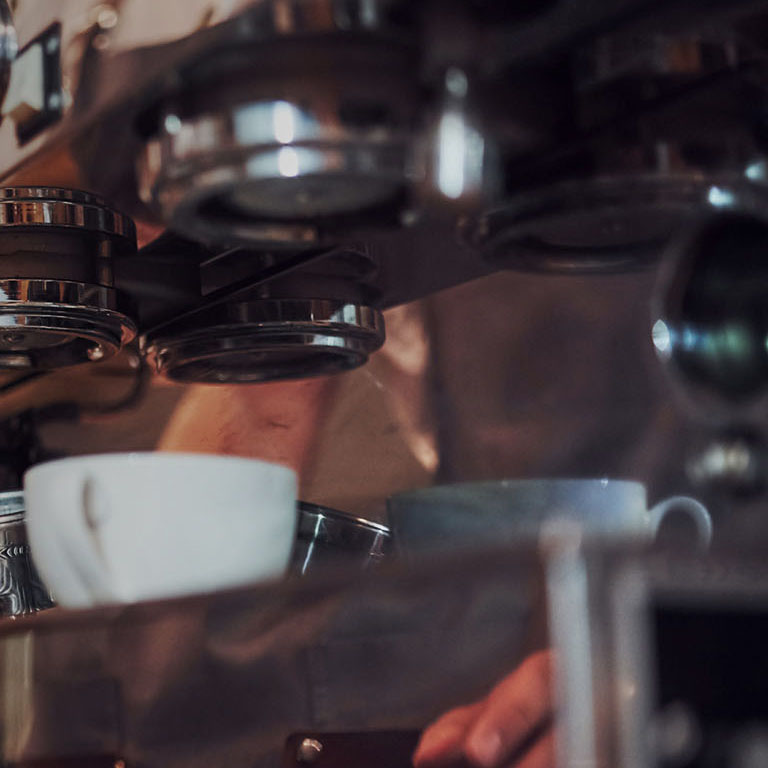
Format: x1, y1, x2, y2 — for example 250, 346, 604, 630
138, 95, 419, 245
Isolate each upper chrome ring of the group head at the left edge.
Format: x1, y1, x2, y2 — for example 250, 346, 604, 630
0, 187, 136, 245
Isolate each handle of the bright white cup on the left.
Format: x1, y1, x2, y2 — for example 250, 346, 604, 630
60, 476, 117, 604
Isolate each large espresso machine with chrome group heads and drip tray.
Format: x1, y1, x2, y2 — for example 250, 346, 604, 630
0, 0, 768, 768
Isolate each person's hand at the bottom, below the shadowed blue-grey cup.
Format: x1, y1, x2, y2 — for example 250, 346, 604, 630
413, 651, 555, 768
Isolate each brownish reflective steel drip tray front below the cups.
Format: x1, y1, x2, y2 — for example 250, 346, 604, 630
0, 550, 542, 768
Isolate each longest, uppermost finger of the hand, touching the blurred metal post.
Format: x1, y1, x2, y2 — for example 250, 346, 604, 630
464, 651, 553, 768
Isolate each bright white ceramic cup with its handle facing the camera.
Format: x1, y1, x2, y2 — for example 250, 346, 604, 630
24, 453, 297, 607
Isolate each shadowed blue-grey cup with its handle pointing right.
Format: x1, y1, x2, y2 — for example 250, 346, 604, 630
387, 478, 712, 554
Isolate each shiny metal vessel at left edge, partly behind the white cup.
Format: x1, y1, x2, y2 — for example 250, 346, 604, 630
0, 491, 53, 617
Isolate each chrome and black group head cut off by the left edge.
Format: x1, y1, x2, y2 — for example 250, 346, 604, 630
0, 186, 137, 369
